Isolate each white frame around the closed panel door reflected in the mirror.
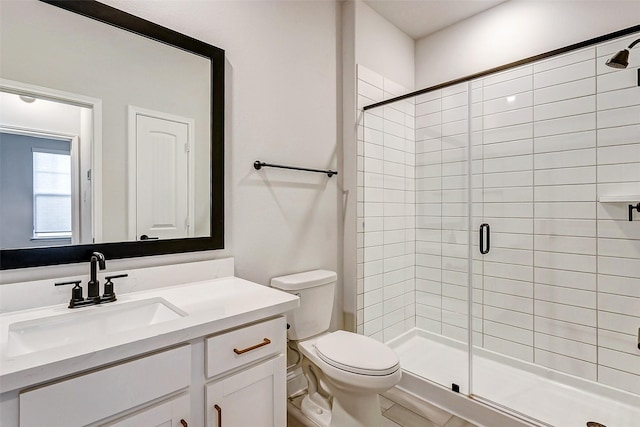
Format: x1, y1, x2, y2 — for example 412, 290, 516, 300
127, 105, 195, 241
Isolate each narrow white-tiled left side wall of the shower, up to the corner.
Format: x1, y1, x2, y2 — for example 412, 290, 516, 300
356, 65, 415, 342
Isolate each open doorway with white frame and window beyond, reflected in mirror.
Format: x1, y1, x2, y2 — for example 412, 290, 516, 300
0, 89, 95, 249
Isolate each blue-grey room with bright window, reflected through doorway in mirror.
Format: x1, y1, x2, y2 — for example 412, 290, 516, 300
0, 128, 80, 248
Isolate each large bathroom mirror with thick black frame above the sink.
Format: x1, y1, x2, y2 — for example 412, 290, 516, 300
0, 0, 224, 269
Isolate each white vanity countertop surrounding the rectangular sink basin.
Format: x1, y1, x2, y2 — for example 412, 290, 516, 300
0, 277, 299, 393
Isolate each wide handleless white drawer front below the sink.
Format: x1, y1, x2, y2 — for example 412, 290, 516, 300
20, 346, 191, 427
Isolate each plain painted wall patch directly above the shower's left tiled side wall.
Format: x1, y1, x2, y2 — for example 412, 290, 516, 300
355, 0, 415, 91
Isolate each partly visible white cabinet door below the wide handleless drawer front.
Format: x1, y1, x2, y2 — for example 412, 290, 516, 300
105, 394, 191, 427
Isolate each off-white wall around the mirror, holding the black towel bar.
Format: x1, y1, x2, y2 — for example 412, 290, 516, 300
2, 0, 342, 324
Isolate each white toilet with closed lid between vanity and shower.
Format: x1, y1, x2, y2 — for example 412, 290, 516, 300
271, 270, 402, 427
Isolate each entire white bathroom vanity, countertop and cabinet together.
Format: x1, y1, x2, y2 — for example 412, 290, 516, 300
0, 274, 299, 427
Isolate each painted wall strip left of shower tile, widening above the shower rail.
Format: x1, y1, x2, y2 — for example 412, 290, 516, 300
342, 0, 415, 330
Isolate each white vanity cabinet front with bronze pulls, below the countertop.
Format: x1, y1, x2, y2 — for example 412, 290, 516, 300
13, 316, 286, 427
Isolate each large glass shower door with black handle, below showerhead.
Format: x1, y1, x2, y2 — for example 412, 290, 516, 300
470, 35, 640, 426
